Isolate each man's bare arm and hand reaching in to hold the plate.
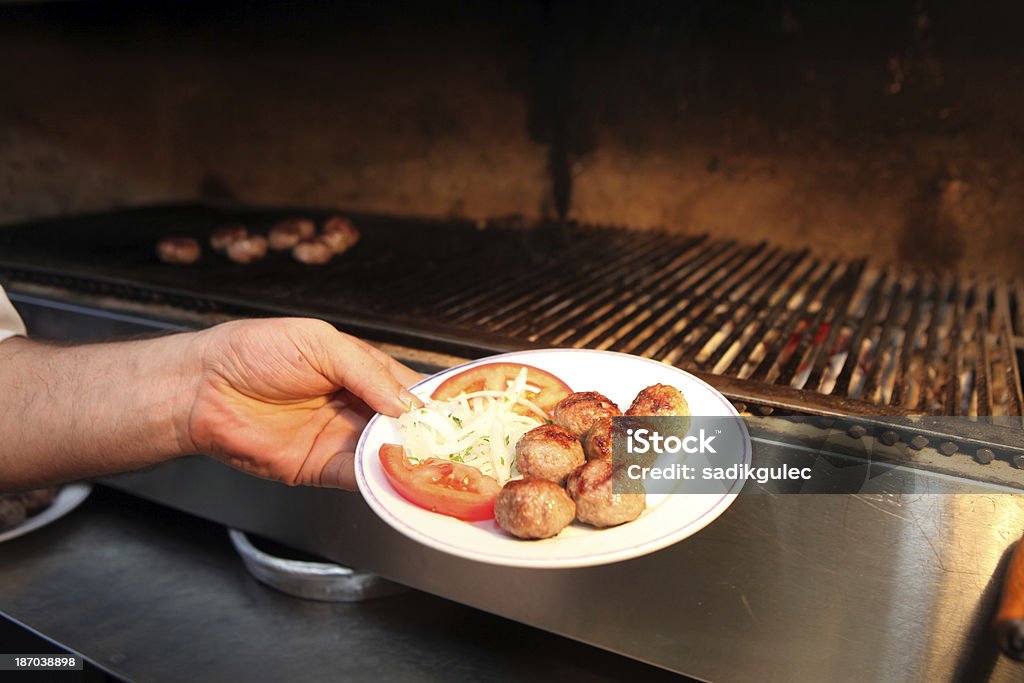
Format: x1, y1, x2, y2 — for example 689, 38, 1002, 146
0, 318, 419, 490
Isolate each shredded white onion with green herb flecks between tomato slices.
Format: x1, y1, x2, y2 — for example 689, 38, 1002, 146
398, 368, 547, 484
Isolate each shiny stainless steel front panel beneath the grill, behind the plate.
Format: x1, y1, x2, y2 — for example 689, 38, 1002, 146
99, 451, 1024, 681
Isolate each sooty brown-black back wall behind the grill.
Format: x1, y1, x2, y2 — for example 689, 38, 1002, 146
0, 0, 1024, 274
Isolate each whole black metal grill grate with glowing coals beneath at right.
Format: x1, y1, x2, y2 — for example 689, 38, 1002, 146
0, 207, 1024, 425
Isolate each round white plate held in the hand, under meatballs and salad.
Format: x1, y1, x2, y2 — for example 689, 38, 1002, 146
355, 349, 751, 568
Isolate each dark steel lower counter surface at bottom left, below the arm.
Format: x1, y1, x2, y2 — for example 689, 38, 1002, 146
0, 487, 677, 683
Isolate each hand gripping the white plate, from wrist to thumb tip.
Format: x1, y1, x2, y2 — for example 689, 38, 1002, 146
184, 318, 422, 489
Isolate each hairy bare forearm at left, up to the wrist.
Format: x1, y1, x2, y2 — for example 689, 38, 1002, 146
0, 335, 199, 492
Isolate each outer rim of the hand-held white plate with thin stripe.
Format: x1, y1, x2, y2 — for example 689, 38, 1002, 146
354, 347, 751, 569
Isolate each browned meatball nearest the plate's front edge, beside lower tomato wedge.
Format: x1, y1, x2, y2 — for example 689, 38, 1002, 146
495, 478, 575, 539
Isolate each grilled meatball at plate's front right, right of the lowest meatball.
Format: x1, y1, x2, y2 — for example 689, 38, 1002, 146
566, 460, 647, 527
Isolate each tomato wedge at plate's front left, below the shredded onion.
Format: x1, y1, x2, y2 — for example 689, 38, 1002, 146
378, 443, 502, 521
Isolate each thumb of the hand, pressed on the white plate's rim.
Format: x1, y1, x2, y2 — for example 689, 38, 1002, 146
315, 333, 420, 417
